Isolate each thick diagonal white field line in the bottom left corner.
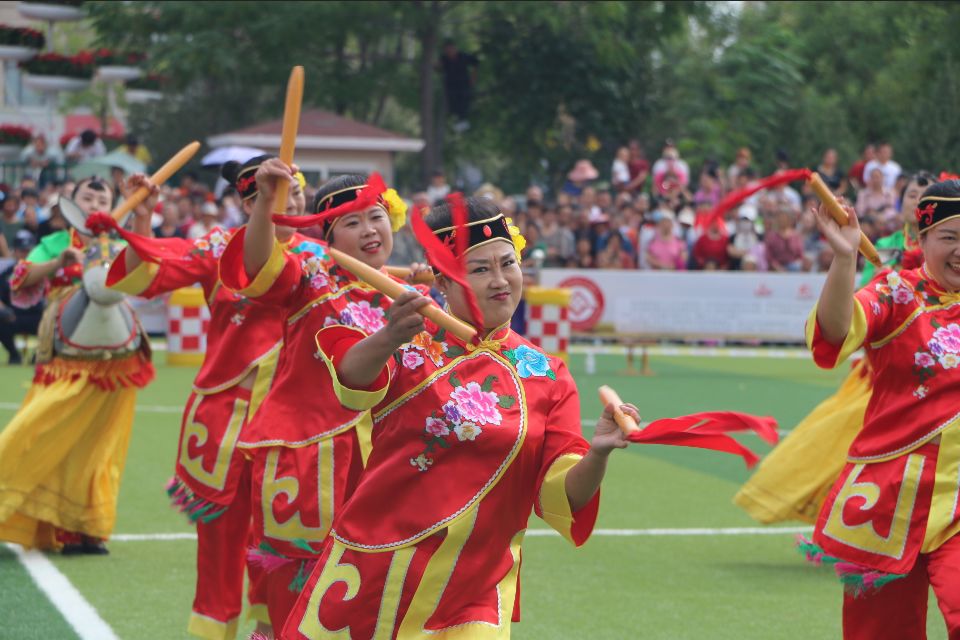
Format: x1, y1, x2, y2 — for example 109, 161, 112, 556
7, 544, 118, 640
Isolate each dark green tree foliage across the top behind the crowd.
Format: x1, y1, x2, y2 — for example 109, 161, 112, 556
85, 0, 960, 189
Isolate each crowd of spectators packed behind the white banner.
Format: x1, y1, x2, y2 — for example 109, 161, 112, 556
444, 140, 910, 272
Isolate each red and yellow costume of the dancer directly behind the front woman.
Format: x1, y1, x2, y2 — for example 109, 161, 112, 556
220, 230, 424, 630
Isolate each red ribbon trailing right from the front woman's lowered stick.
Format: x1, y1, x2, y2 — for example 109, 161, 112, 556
627, 411, 779, 467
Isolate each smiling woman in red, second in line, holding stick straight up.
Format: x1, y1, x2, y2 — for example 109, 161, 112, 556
220, 159, 424, 630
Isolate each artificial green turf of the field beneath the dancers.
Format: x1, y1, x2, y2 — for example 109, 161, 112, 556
0, 354, 946, 640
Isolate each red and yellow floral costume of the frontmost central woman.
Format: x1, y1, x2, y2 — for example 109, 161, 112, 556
280, 327, 599, 640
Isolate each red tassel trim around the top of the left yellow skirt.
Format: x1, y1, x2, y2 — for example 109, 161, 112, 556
33, 353, 156, 391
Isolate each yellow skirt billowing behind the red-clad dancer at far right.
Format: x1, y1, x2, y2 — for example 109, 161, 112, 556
733, 360, 873, 524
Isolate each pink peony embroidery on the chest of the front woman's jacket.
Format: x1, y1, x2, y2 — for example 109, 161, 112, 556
409, 376, 517, 471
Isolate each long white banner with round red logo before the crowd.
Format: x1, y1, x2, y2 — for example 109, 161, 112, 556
540, 269, 826, 342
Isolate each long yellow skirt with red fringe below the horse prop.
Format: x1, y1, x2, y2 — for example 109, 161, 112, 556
0, 355, 153, 548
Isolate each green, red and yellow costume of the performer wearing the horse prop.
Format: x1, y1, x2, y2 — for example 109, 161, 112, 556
0, 231, 154, 549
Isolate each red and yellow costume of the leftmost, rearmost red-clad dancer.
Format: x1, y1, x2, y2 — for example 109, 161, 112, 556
108, 228, 315, 639
